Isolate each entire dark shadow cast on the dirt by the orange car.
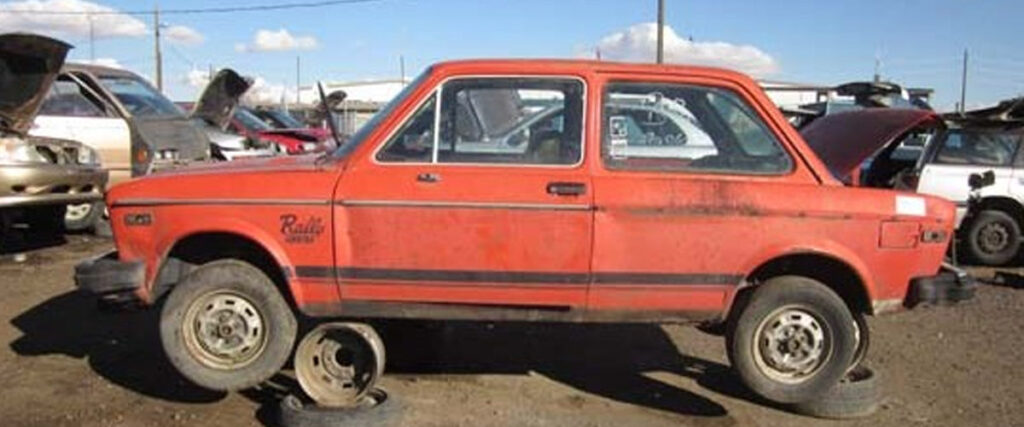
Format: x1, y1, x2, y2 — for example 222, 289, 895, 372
10, 292, 777, 425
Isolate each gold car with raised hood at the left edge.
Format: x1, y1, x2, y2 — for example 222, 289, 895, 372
0, 33, 108, 236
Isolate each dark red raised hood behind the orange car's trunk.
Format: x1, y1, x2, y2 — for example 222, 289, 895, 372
800, 109, 939, 178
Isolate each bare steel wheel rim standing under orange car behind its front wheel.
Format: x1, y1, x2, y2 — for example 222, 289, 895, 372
295, 324, 383, 407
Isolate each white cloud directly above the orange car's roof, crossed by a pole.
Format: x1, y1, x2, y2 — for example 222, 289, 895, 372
597, 23, 779, 76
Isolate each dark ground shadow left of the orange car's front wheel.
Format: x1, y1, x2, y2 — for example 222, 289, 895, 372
10, 292, 225, 402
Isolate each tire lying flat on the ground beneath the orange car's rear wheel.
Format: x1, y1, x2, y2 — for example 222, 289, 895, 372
790, 366, 882, 420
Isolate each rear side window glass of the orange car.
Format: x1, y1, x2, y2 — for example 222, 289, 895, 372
602, 83, 793, 174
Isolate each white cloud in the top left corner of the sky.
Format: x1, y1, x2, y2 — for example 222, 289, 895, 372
0, 0, 150, 37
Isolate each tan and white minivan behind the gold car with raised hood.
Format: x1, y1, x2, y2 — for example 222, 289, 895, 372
30, 63, 210, 229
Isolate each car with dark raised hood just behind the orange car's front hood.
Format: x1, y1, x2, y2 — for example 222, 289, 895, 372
188, 69, 284, 161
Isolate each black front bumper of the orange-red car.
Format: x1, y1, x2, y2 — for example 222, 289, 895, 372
75, 251, 145, 305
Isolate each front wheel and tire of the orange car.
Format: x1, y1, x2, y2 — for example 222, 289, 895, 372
160, 259, 298, 391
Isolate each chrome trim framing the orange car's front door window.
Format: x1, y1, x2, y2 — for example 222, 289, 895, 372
370, 74, 590, 170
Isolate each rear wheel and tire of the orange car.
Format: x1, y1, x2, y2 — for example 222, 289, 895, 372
725, 275, 857, 403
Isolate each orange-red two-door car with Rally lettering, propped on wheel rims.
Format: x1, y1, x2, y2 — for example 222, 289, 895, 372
76, 60, 974, 402
